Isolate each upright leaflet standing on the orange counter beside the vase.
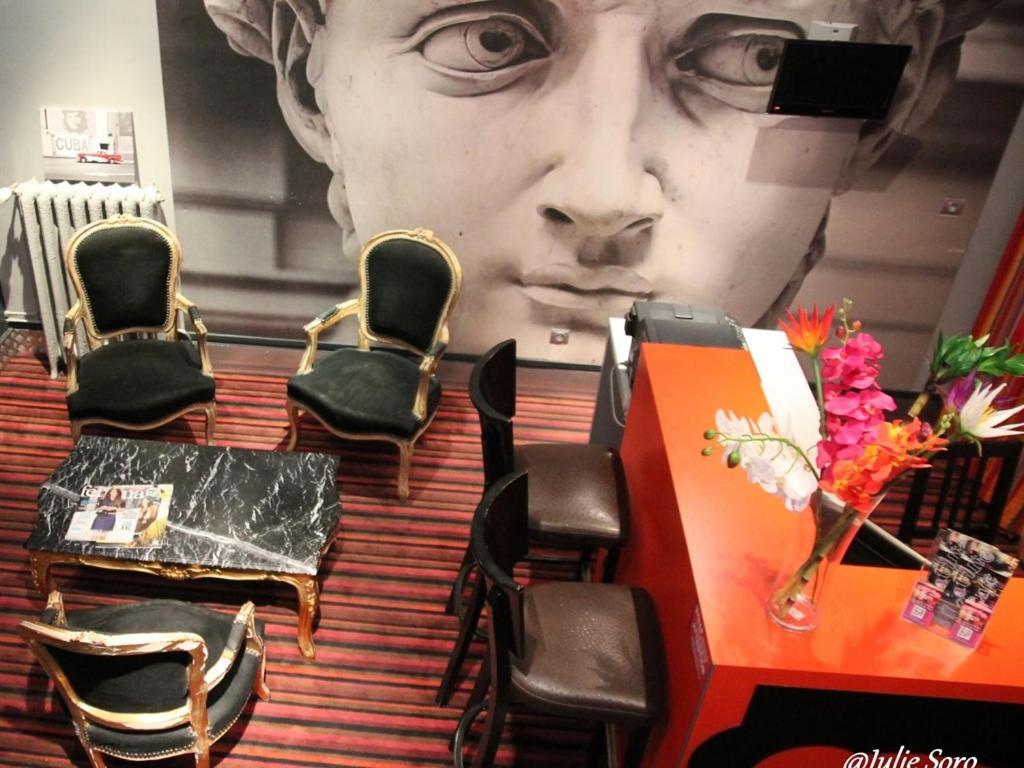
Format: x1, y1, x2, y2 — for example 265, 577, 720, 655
903, 529, 1019, 648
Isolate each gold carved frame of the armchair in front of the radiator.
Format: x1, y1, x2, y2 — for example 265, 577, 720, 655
63, 214, 217, 445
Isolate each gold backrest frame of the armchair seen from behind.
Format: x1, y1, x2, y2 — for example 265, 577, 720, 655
18, 622, 207, 730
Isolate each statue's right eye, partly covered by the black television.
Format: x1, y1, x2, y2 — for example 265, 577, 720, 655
674, 34, 785, 86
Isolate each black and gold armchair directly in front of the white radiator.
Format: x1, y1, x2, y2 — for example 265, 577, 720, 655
63, 215, 217, 443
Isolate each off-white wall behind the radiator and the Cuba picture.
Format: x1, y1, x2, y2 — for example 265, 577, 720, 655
0, 0, 174, 321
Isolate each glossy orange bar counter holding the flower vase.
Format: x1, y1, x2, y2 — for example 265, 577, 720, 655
620, 345, 1024, 767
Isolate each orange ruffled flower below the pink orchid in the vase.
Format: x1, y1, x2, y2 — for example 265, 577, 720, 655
821, 419, 948, 512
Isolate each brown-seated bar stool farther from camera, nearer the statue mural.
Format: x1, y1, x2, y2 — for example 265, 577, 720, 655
435, 339, 629, 705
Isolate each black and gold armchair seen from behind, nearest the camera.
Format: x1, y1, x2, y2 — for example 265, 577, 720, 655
19, 592, 270, 768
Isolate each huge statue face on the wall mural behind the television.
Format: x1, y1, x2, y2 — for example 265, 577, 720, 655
206, 0, 1003, 357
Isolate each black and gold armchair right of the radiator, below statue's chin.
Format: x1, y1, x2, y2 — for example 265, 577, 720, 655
288, 229, 462, 499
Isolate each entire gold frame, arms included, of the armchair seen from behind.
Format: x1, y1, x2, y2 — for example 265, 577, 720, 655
18, 591, 270, 768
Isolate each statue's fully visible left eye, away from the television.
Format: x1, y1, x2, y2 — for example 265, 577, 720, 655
420, 16, 550, 74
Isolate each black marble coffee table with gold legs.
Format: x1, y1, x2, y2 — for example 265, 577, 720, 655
25, 436, 341, 658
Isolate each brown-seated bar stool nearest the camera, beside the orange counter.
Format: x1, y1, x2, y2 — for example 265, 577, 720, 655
452, 472, 666, 768
